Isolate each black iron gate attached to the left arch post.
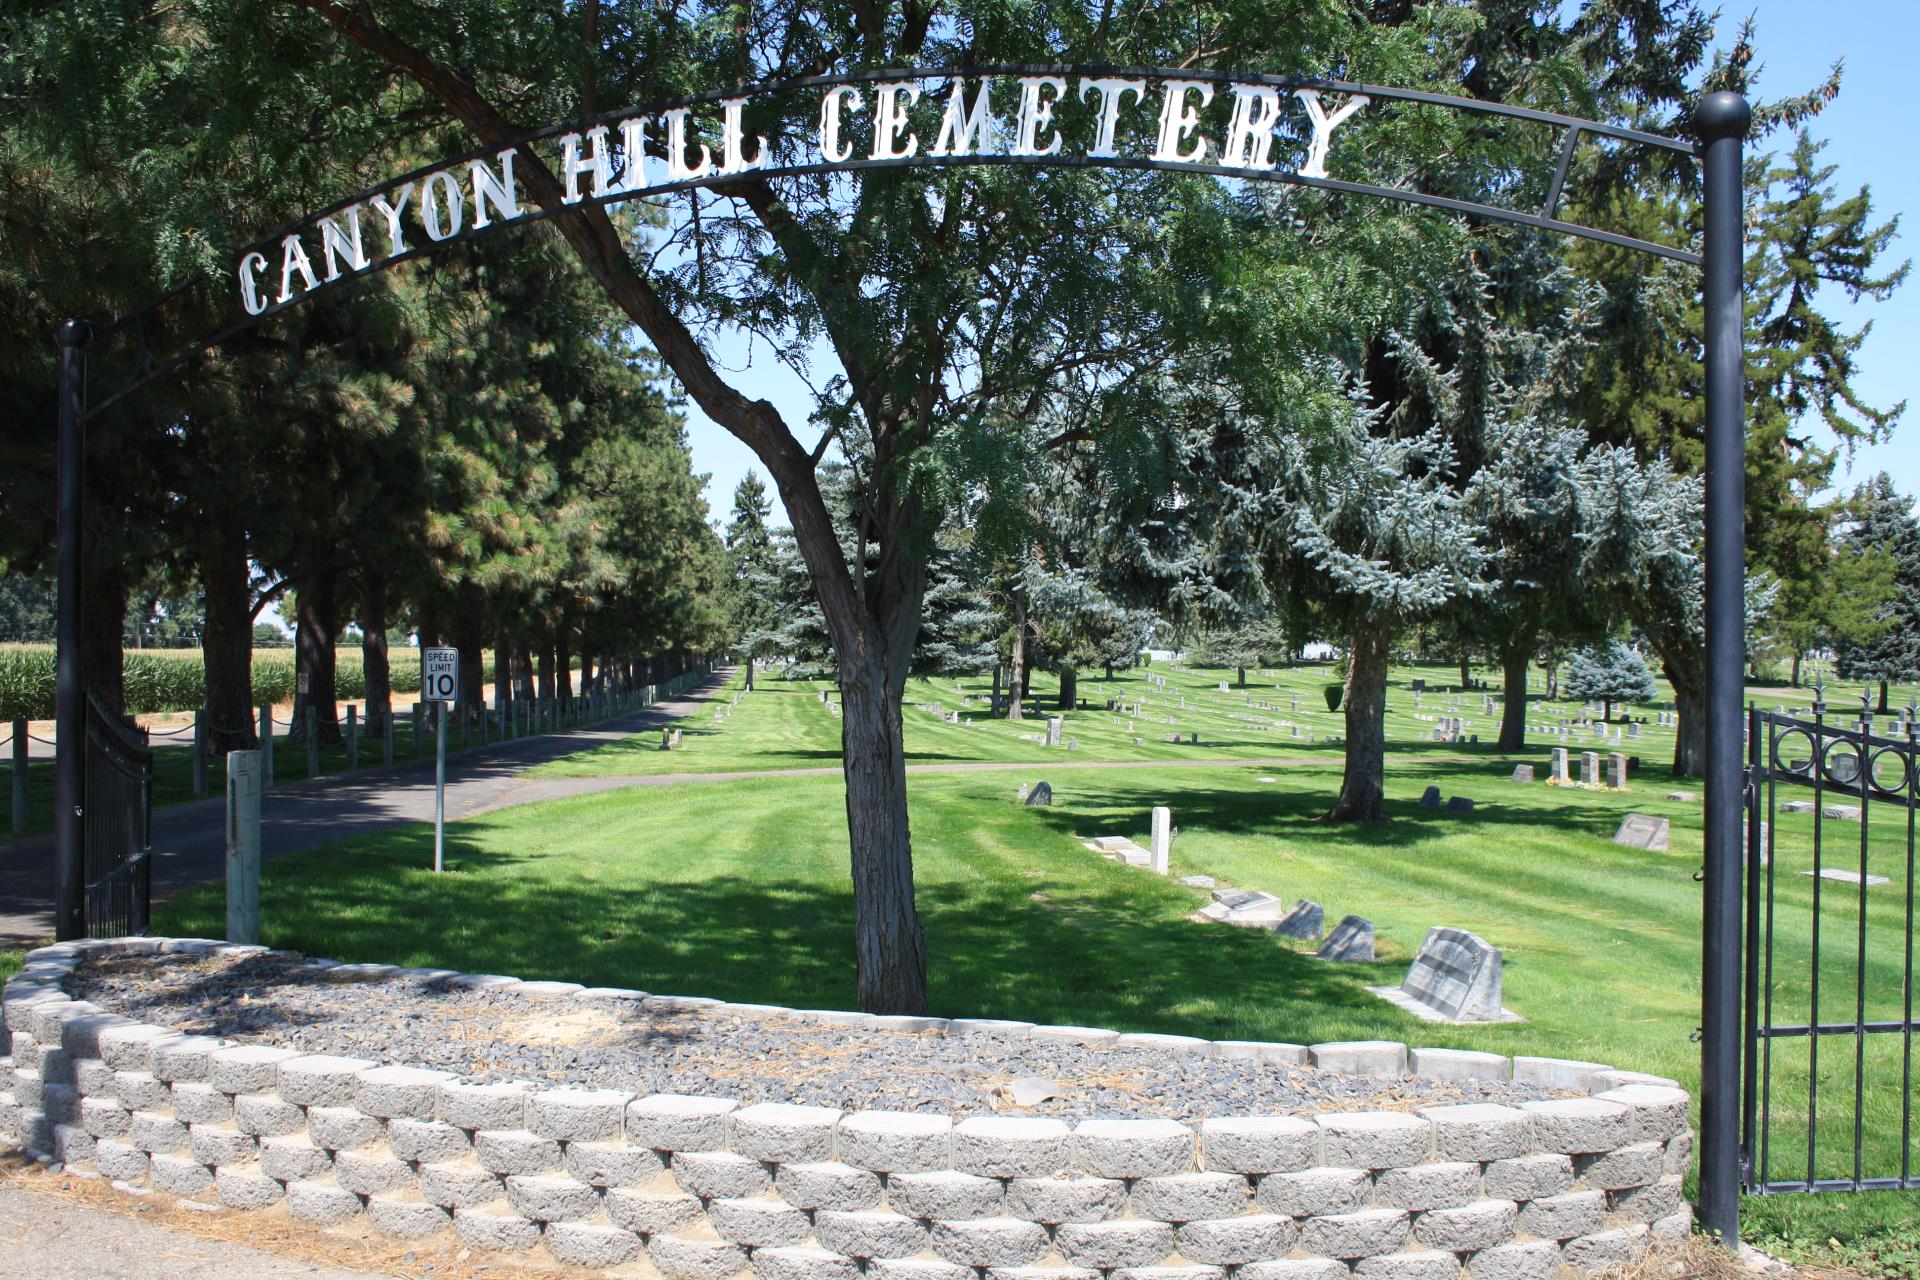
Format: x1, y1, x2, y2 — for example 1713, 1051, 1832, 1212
83, 697, 154, 938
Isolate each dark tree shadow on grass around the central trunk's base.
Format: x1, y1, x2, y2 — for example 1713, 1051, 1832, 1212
156, 831, 1392, 1038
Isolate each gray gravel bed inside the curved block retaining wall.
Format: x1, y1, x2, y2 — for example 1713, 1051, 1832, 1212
69, 952, 1555, 1121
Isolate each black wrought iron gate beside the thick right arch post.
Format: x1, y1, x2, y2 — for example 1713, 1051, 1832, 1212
1741, 697, 1920, 1196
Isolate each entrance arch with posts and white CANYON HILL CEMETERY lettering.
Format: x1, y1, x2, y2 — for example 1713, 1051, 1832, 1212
45, 65, 1749, 1238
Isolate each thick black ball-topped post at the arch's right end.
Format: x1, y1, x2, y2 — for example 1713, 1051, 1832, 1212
1693, 92, 1751, 1245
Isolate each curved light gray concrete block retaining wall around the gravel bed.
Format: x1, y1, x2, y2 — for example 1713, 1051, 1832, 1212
0, 938, 1692, 1280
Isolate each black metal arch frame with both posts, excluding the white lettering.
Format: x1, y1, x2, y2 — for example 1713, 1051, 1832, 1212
54, 65, 1749, 1242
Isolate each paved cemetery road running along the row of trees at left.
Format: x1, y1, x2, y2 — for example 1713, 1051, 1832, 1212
0, 672, 726, 948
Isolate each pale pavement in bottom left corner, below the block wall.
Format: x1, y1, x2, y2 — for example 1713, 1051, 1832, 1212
0, 1184, 386, 1280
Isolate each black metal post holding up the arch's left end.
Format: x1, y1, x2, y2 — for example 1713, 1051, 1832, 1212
54, 320, 94, 942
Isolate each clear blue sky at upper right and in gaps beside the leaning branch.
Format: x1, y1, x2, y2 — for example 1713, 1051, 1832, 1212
687, 0, 1920, 520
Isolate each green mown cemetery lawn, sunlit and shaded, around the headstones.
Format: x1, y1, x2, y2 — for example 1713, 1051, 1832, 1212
45, 668, 1920, 1274
